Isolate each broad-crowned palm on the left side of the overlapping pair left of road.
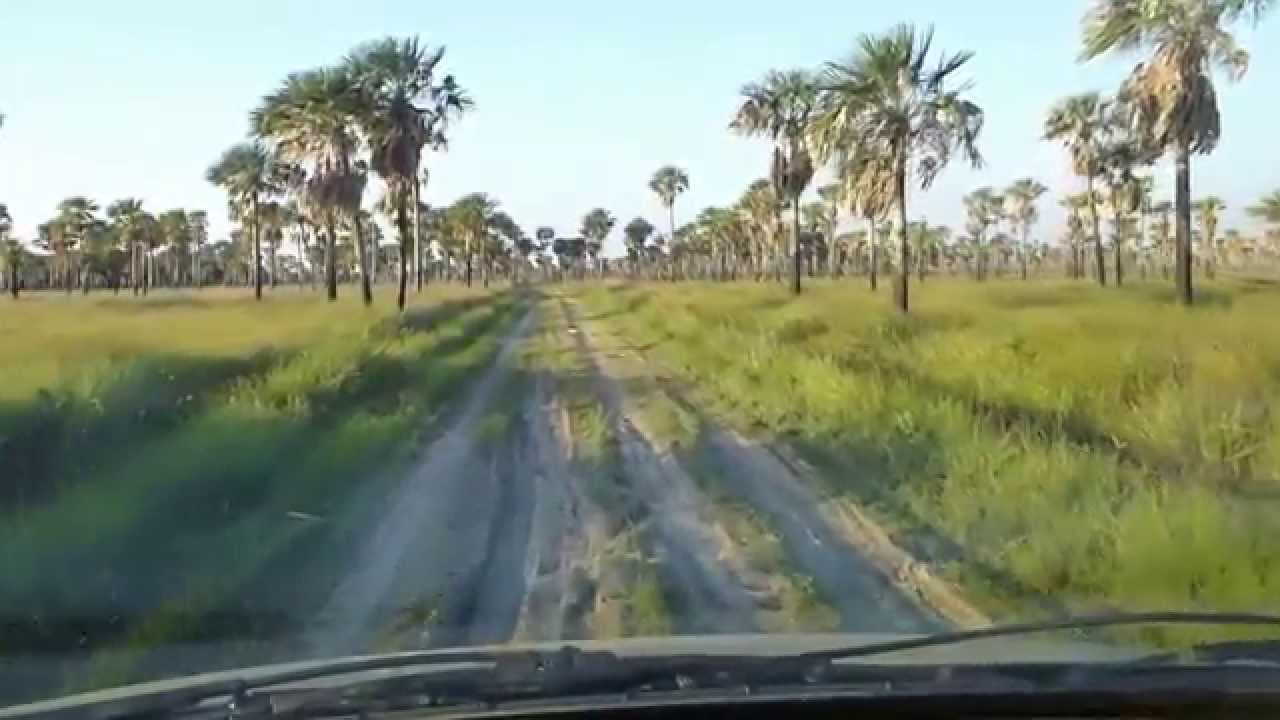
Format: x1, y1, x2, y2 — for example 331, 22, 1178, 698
250, 68, 372, 305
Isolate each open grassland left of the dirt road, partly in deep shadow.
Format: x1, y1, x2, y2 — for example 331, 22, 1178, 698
0, 288, 522, 687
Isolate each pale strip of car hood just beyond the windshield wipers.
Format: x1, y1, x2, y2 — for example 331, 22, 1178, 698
0, 633, 1143, 719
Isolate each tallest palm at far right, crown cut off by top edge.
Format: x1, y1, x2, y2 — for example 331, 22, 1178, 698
1082, 0, 1271, 305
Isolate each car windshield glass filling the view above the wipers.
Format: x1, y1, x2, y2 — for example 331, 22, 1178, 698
0, 0, 1280, 706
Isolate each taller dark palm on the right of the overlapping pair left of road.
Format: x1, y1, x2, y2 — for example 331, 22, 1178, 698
347, 37, 471, 310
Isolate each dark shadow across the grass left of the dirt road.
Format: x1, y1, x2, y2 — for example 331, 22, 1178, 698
0, 293, 517, 671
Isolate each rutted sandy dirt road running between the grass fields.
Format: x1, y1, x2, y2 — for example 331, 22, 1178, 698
299, 293, 940, 656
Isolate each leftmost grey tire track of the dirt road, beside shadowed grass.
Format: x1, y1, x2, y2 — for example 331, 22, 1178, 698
307, 304, 534, 657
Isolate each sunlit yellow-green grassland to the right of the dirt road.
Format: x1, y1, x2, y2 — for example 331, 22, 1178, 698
573, 278, 1280, 644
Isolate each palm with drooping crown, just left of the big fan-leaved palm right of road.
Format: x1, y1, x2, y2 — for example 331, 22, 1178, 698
730, 70, 818, 295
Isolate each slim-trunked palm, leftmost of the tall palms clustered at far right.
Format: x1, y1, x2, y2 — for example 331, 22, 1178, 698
1044, 92, 1110, 287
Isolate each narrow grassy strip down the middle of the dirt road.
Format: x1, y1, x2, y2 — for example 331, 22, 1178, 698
527, 299, 673, 639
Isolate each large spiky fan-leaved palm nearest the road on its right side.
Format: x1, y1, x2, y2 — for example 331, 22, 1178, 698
813, 24, 983, 313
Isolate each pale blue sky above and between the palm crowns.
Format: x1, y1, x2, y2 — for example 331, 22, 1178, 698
0, 0, 1280, 254
